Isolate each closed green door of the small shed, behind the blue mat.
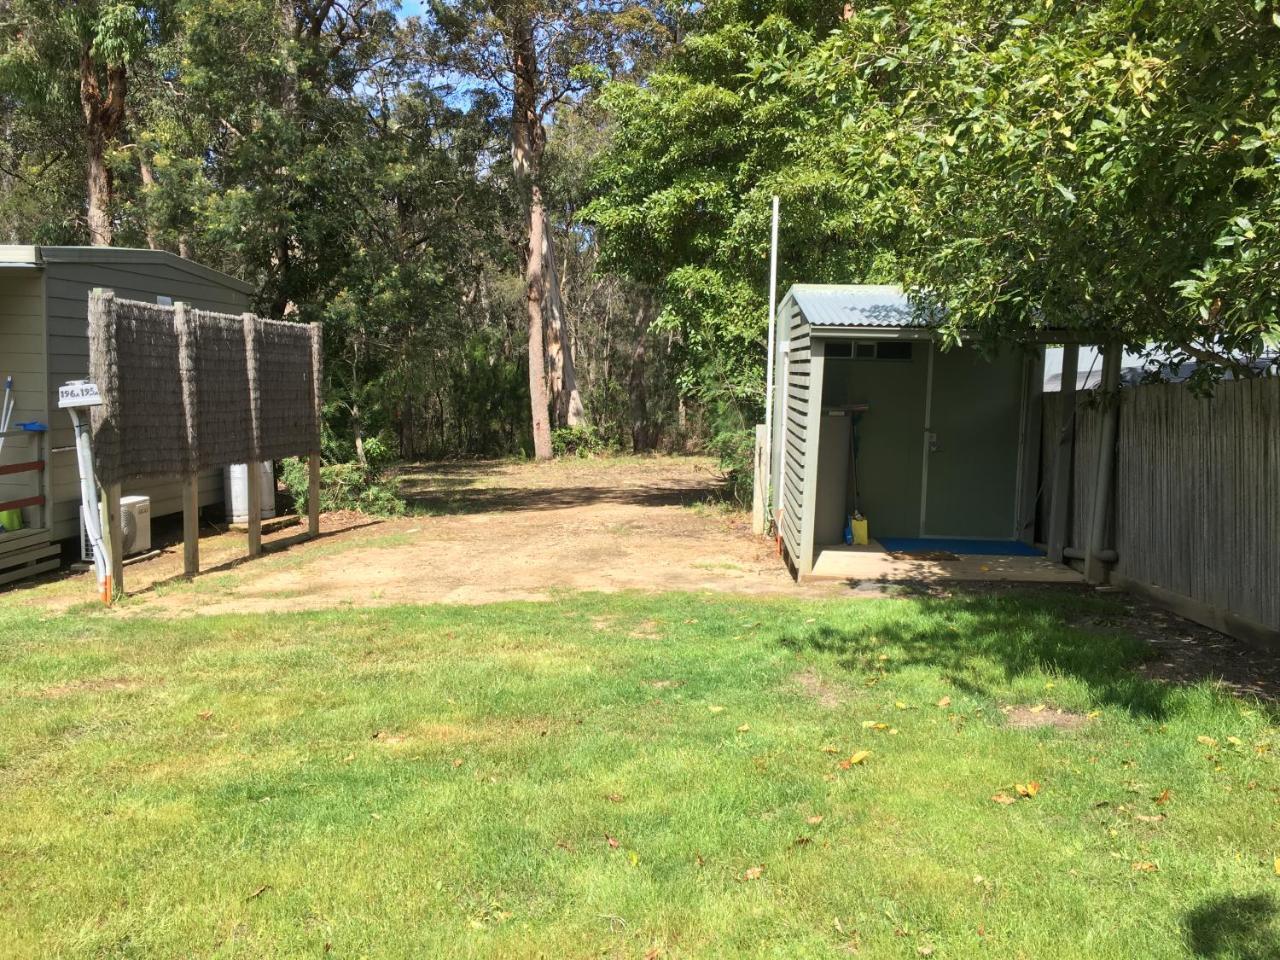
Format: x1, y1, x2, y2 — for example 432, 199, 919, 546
923, 349, 1023, 540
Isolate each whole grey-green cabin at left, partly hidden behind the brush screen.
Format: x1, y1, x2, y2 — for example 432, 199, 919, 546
0, 246, 252, 582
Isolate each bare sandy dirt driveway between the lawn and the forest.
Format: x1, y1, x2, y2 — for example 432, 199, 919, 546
15, 457, 849, 614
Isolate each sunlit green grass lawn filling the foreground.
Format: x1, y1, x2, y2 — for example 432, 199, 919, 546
0, 593, 1280, 960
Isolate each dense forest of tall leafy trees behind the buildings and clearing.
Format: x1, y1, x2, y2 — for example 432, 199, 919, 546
0, 0, 1280, 481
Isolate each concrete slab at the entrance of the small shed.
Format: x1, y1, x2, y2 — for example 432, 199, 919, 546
805, 540, 1084, 584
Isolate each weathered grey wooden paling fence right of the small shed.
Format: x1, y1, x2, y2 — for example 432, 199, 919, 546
1039, 378, 1280, 634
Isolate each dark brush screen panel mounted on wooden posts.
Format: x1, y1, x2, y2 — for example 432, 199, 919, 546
88, 284, 320, 483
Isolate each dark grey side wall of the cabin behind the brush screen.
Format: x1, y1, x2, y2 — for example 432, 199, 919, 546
45, 257, 250, 539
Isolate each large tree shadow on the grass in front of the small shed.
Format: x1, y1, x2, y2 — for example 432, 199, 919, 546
781, 591, 1171, 719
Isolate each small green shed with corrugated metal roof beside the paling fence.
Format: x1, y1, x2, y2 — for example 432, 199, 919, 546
769, 284, 1043, 577
